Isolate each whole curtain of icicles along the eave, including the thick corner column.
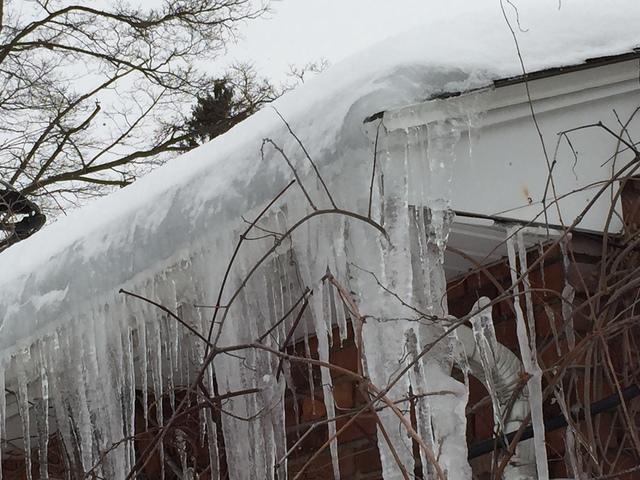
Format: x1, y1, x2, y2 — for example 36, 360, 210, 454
0, 109, 480, 479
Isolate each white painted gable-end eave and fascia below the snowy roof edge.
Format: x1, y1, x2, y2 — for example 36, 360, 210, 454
367, 51, 640, 233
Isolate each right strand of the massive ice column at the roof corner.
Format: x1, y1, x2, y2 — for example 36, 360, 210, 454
414, 120, 471, 479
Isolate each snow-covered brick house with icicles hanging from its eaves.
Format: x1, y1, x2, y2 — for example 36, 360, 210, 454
0, 5, 640, 480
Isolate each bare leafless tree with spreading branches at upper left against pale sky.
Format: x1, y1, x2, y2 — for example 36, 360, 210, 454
0, 0, 266, 211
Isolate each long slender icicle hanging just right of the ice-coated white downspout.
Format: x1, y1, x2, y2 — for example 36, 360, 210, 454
507, 227, 549, 480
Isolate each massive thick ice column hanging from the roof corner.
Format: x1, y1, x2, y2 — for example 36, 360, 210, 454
354, 120, 471, 479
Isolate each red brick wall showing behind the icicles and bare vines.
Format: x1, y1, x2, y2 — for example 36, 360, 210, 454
286, 235, 632, 479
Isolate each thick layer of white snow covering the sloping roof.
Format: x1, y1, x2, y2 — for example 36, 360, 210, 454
0, 0, 640, 355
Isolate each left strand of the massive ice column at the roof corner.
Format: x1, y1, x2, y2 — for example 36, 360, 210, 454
362, 125, 414, 480
